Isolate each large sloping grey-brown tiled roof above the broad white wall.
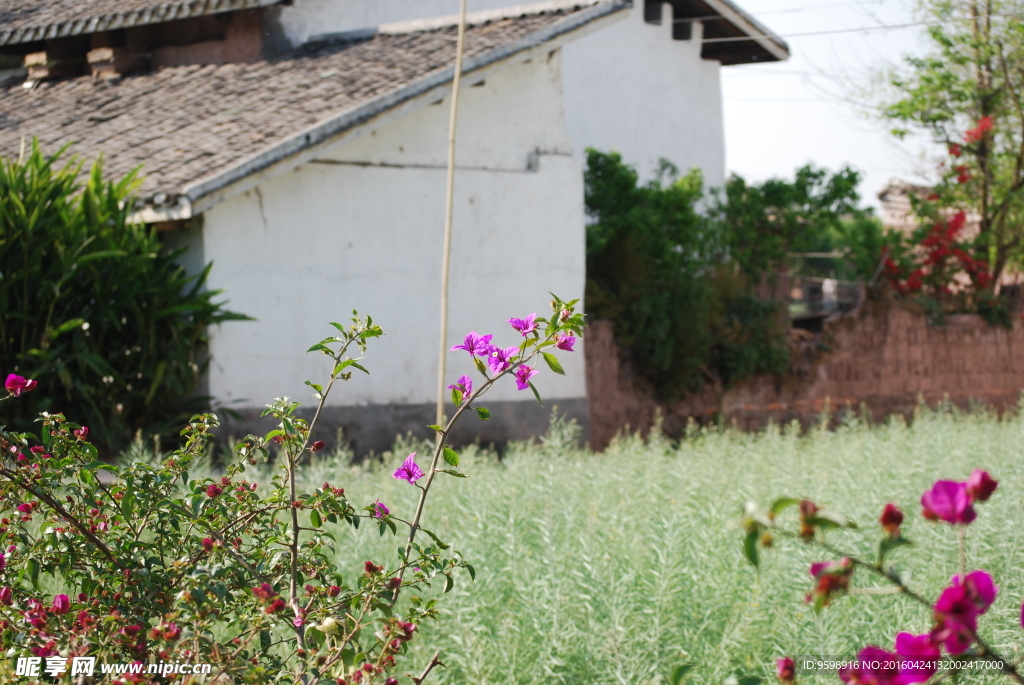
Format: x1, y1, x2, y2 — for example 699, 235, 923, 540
0, 2, 626, 213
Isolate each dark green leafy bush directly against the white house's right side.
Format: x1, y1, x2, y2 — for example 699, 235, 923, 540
586, 149, 788, 400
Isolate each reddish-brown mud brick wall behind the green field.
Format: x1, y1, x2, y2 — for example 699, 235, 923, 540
586, 301, 1024, 448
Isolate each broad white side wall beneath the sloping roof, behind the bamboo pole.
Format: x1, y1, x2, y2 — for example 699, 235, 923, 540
203, 52, 586, 406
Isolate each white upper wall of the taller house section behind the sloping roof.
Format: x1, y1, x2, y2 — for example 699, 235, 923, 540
281, 0, 725, 186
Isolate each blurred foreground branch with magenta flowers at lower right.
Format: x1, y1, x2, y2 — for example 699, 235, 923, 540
742, 470, 1024, 685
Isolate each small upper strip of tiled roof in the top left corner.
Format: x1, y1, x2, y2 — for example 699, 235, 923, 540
0, 0, 278, 45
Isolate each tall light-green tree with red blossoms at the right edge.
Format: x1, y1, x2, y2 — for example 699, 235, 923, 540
882, 0, 1024, 286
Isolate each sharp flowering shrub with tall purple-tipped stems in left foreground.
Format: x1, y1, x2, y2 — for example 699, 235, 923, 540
0, 298, 583, 685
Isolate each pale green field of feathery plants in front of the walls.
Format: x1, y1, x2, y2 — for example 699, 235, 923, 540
307, 411, 1024, 685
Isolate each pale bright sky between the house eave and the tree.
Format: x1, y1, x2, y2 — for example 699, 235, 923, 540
722, 0, 934, 205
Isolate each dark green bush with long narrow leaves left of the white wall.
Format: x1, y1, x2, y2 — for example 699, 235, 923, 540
0, 142, 244, 446
